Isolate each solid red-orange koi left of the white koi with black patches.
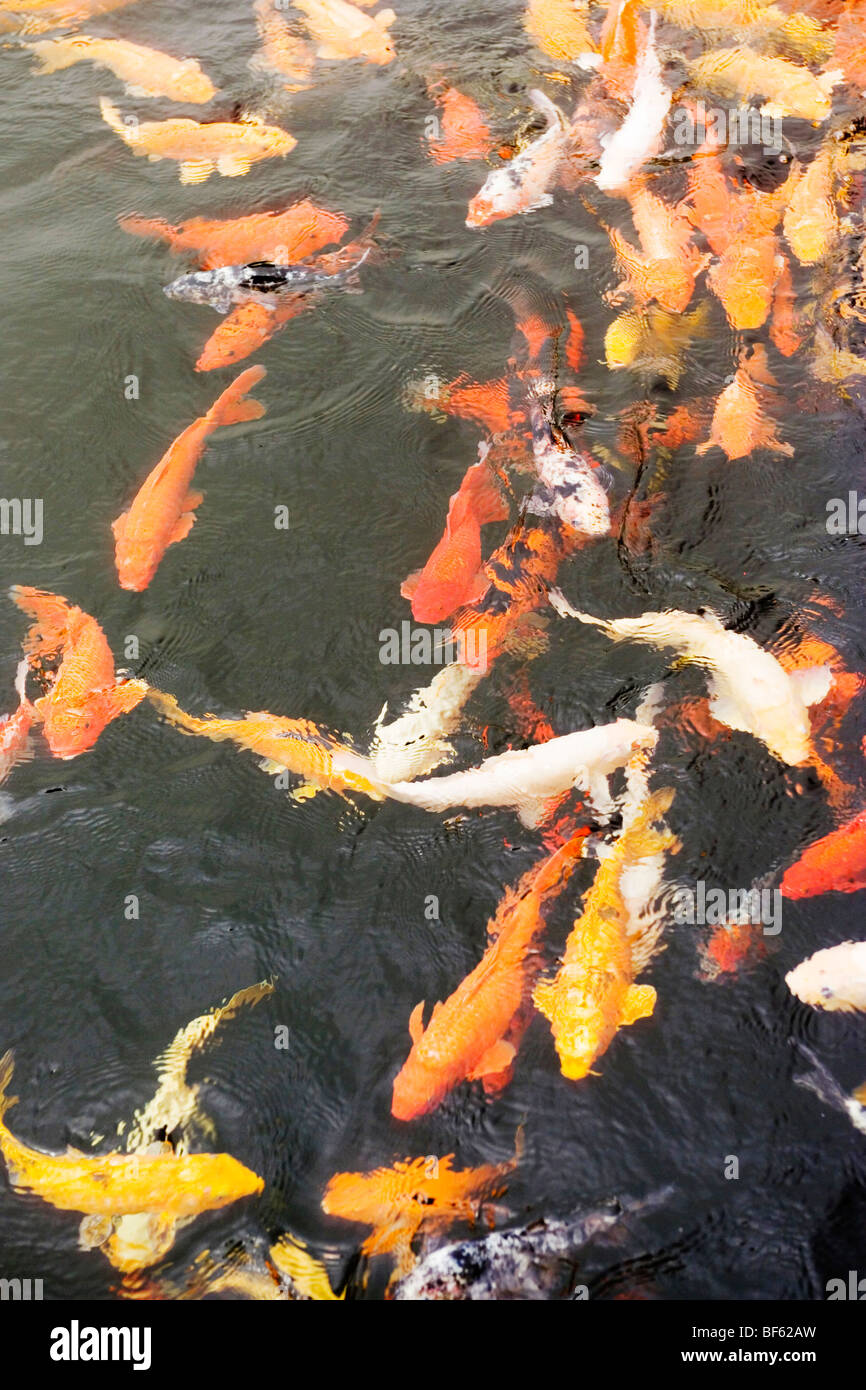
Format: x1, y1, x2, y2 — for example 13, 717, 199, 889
400, 445, 509, 623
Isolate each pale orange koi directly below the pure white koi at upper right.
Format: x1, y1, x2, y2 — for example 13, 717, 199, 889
609, 182, 710, 314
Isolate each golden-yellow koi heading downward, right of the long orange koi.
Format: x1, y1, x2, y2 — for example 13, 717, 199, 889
532, 788, 680, 1081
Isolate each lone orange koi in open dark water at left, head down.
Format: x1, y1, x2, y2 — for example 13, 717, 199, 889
111, 367, 265, 594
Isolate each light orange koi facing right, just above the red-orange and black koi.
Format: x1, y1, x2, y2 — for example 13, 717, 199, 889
99, 96, 297, 183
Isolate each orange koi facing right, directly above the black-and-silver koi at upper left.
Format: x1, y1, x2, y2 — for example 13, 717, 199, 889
118, 199, 349, 270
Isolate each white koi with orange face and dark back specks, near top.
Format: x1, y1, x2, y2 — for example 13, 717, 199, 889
466, 90, 570, 227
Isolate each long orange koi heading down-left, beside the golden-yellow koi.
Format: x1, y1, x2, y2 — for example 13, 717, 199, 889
391, 830, 587, 1120
